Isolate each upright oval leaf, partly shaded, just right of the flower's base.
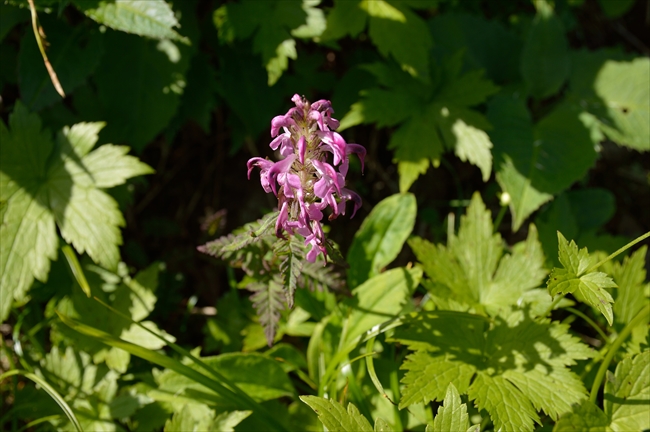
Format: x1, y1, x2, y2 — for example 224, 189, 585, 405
348, 193, 417, 288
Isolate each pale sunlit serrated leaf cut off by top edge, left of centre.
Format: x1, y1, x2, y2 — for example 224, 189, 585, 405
73, 0, 189, 44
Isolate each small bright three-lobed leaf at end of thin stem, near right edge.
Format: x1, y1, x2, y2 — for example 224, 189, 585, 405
547, 231, 617, 325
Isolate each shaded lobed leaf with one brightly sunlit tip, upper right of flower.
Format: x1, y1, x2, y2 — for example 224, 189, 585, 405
341, 51, 498, 192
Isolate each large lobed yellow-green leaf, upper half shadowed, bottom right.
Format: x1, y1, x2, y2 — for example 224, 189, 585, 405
392, 308, 593, 431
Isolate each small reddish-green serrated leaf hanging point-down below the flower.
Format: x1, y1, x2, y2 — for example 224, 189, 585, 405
247, 279, 286, 346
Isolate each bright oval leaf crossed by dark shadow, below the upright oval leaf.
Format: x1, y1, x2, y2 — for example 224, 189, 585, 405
345, 267, 422, 341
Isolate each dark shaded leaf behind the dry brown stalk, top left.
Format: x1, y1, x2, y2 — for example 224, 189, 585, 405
18, 18, 103, 111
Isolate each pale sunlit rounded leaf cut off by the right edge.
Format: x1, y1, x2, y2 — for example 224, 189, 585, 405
594, 57, 650, 151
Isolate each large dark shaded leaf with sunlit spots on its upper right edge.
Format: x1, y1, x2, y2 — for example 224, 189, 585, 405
94, 31, 189, 150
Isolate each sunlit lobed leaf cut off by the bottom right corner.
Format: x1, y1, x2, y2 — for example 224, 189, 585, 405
553, 351, 650, 432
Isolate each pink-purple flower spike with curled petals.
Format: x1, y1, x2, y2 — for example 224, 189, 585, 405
248, 94, 366, 262
